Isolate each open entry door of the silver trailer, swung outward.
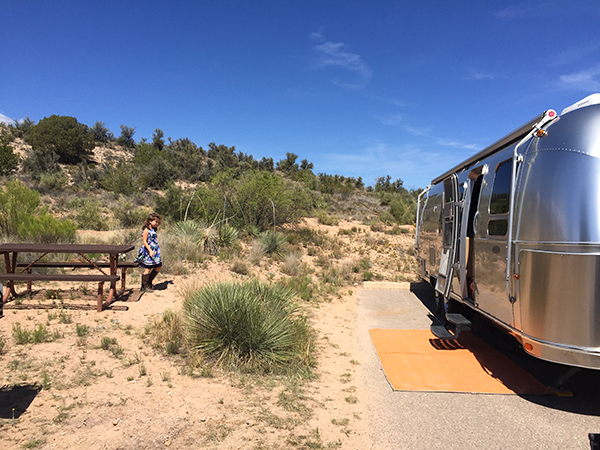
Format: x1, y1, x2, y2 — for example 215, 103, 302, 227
435, 174, 459, 297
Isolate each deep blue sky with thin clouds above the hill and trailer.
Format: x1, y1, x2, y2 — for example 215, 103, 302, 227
0, 0, 600, 188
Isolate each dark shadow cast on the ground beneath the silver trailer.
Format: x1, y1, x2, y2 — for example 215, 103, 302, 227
411, 282, 600, 416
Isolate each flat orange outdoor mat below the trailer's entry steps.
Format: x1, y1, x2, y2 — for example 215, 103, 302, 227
369, 329, 551, 394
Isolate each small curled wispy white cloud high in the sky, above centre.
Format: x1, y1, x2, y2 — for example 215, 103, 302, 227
309, 31, 373, 89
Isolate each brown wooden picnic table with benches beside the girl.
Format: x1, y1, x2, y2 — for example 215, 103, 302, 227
0, 244, 135, 312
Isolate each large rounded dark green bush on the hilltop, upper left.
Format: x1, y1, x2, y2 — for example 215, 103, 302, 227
29, 115, 94, 164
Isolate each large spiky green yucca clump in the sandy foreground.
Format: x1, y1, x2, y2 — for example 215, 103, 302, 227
183, 282, 313, 372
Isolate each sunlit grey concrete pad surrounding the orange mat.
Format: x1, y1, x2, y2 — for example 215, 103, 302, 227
356, 283, 600, 450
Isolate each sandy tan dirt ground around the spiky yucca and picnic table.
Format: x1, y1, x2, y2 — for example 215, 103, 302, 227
0, 220, 414, 449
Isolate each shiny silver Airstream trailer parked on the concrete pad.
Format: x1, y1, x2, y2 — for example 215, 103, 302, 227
416, 94, 600, 369
